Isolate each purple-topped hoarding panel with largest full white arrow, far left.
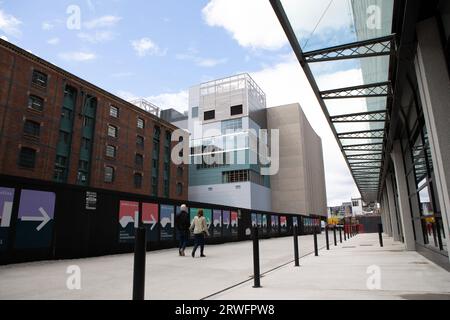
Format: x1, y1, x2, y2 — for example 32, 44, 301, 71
15, 189, 56, 249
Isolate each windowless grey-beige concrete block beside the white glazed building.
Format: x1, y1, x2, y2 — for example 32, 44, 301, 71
267, 103, 327, 216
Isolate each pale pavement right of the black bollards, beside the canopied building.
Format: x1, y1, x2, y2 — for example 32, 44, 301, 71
213, 234, 450, 300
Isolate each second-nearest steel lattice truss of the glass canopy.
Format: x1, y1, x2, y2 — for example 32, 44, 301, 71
320, 82, 391, 99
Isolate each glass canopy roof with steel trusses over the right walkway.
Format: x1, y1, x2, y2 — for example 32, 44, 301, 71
270, 0, 395, 202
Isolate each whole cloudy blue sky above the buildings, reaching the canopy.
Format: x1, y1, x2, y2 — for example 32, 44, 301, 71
0, 0, 361, 205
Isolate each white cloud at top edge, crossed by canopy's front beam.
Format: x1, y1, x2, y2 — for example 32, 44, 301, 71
202, 0, 351, 50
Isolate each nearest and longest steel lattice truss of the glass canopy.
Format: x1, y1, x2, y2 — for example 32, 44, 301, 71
304, 35, 394, 63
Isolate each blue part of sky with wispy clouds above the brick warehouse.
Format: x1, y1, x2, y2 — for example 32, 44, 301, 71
0, 0, 289, 104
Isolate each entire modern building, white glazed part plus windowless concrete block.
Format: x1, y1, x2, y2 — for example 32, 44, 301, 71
184, 74, 327, 216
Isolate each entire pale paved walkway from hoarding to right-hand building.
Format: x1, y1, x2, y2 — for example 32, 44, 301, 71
0, 234, 450, 299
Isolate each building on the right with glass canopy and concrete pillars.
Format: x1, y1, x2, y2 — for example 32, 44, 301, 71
270, 0, 450, 268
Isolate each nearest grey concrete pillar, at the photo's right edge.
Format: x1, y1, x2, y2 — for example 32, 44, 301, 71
415, 18, 450, 258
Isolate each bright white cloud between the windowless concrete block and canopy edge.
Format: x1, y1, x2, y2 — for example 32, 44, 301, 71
251, 57, 359, 205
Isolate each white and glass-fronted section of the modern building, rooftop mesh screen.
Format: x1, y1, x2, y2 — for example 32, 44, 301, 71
188, 74, 271, 211
